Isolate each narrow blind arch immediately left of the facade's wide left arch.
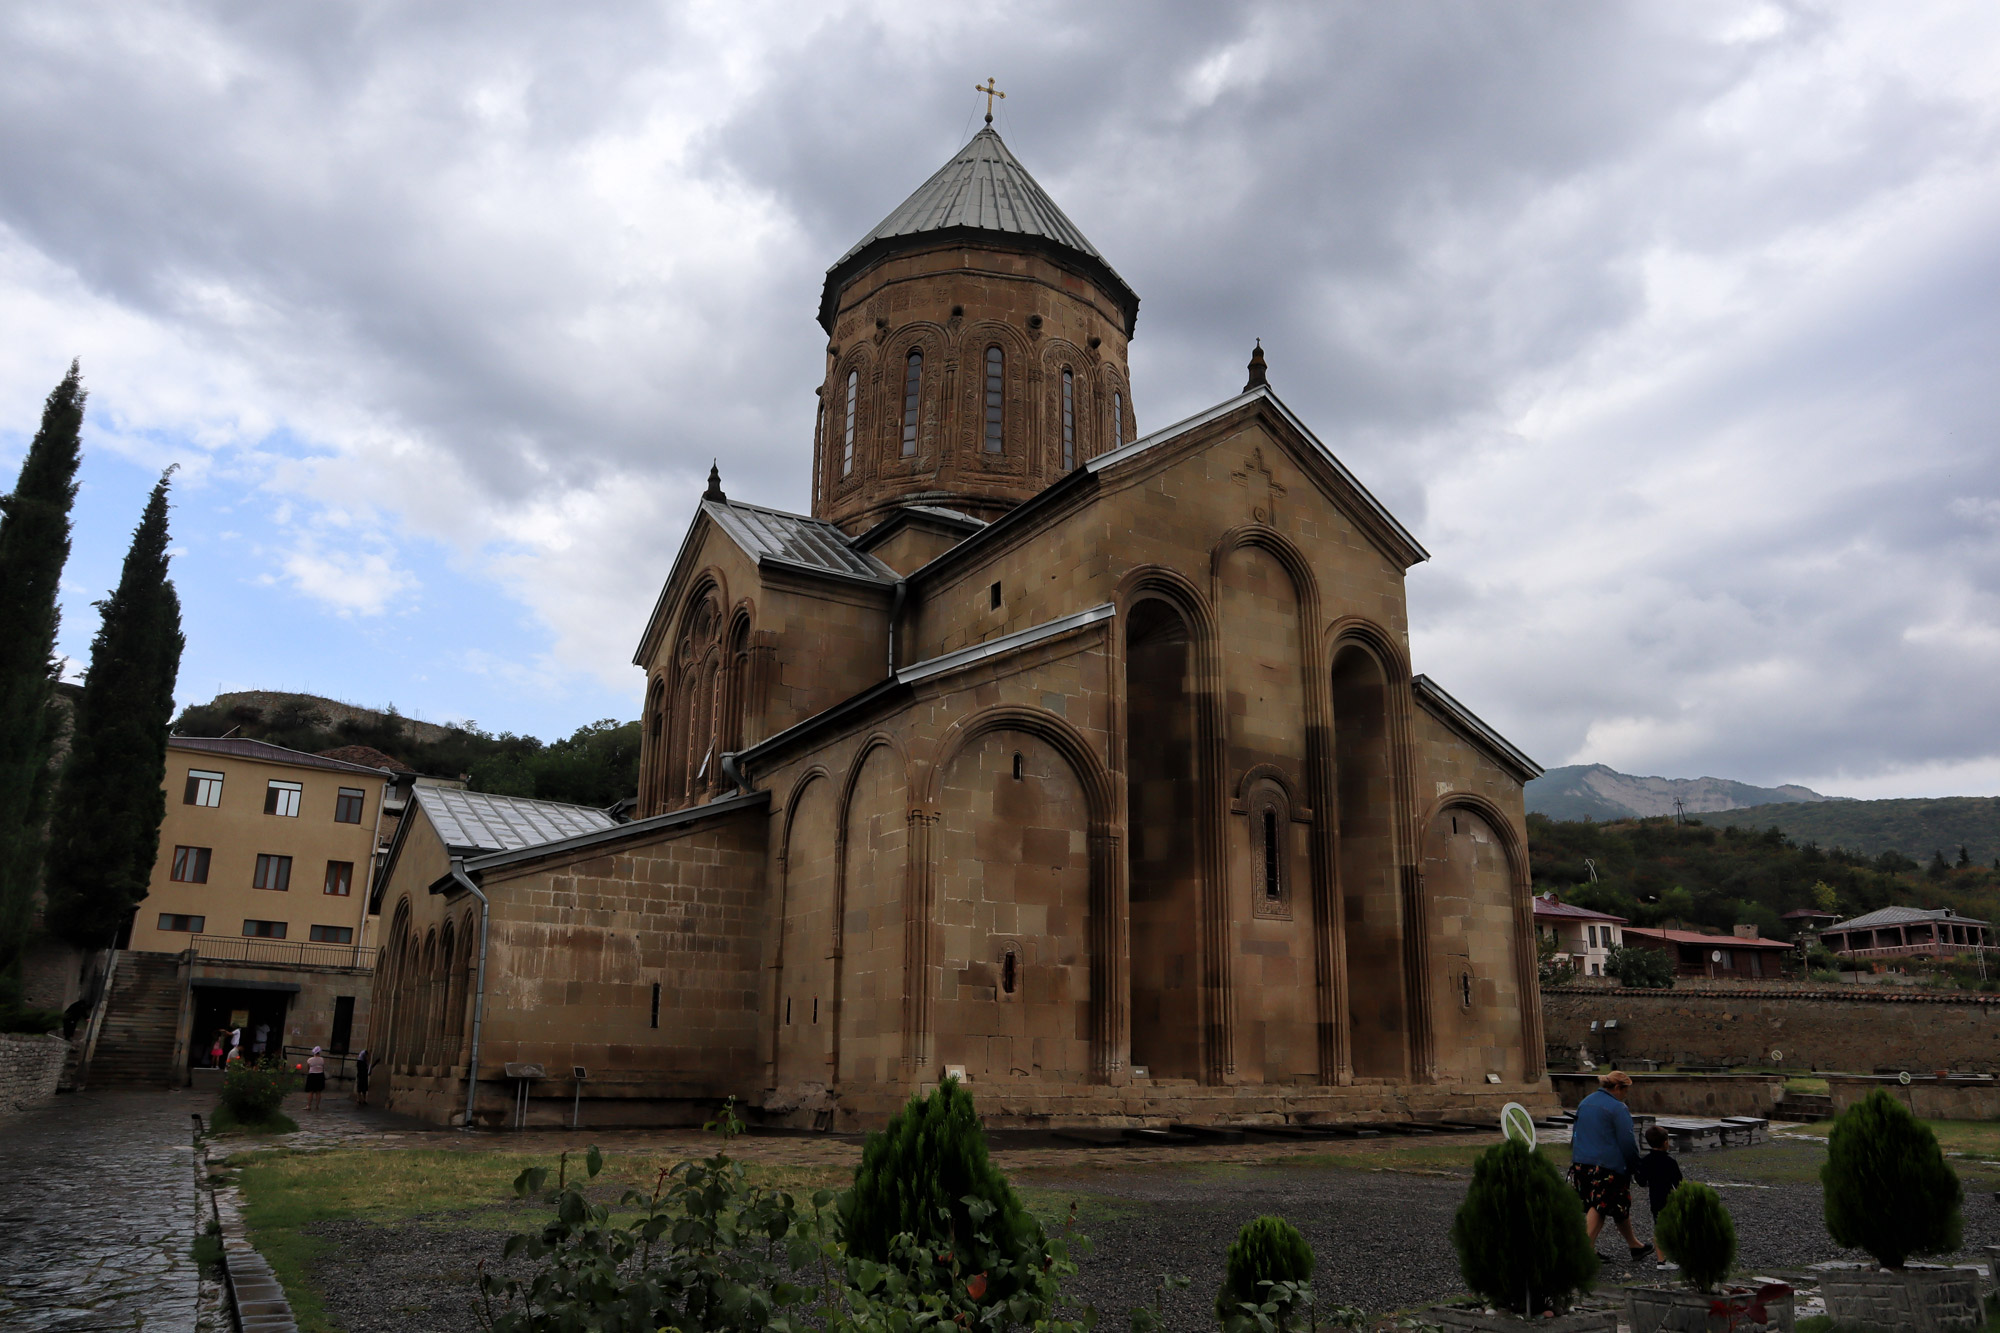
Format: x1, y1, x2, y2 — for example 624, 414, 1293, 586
832, 733, 910, 1083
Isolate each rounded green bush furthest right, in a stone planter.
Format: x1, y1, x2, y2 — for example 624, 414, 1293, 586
1820, 1089, 1966, 1269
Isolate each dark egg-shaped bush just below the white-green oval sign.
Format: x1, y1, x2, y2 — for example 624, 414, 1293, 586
1452, 1139, 1598, 1315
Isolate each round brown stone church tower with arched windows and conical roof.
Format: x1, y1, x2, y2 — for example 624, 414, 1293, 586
812, 126, 1138, 534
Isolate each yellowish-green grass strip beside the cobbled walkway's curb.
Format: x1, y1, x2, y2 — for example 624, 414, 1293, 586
230, 1149, 856, 1333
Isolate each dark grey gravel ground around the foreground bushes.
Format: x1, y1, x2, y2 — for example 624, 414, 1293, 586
296, 1153, 2000, 1333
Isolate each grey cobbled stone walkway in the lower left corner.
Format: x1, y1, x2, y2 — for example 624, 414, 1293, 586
0, 1091, 208, 1333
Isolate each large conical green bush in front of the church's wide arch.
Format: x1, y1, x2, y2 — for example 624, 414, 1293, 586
840, 1079, 1044, 1299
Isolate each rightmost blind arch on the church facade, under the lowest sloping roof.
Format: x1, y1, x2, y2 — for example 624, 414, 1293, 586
1422, 793, 1544, 1083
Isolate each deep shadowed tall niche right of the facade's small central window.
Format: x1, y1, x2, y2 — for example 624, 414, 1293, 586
1332, 634, 1412, 1081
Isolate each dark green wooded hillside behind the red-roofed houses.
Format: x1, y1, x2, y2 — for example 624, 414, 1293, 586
1528, 805, 2000, 939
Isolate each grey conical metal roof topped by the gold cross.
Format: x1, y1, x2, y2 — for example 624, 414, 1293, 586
820, 126, 1138, 332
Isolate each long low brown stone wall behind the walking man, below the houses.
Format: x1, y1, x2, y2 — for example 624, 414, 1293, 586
1542, 987, 2000, 1073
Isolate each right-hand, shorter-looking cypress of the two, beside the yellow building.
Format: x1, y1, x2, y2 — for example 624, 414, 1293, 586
46, 468, 186, 949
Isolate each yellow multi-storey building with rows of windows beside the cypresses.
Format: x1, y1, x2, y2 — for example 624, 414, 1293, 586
90, 737, 392, 1083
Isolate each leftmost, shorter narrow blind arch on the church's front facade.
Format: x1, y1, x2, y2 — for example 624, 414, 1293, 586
772, 765, 838, 1087
